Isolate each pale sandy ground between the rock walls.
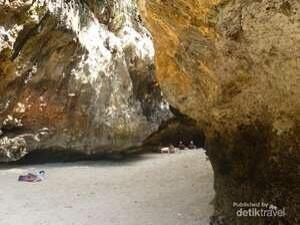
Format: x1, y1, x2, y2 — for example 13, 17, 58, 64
0, 150, 214, 225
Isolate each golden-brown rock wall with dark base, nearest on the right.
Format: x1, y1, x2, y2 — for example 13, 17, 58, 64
139, 0, 300, 225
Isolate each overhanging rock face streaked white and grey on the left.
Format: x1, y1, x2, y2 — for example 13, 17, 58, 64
0, 0, 172, 162
